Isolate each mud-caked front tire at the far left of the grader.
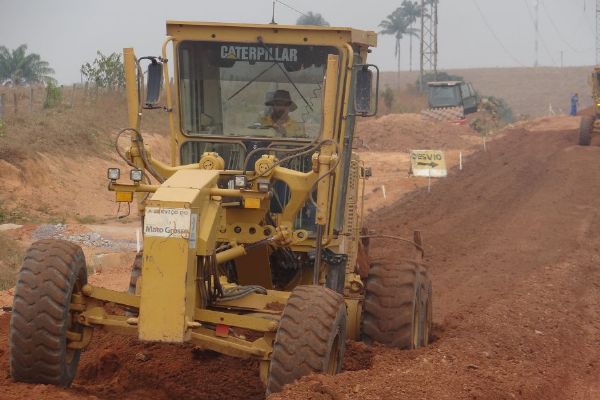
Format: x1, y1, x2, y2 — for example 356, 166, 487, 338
9, 240, 87, 387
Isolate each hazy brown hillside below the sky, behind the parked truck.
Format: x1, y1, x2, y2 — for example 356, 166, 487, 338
382, 67, 592, 116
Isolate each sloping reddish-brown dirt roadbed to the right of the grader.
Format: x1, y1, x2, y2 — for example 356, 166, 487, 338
275, 121, 600, 400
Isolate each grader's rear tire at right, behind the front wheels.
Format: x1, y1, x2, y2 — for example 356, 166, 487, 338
362, 261, 432, 349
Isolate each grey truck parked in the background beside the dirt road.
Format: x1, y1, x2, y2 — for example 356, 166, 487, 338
421, 81, 479, 125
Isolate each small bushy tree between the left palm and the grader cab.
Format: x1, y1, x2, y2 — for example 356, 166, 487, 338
81, 51, 125, 89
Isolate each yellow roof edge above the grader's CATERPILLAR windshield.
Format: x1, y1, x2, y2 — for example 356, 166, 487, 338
167, 20, 377, 47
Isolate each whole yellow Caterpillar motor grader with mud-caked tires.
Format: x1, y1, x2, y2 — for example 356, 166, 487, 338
10, 21, 432, 394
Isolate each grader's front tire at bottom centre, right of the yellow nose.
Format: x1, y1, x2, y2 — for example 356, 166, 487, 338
267, 286, 346, 396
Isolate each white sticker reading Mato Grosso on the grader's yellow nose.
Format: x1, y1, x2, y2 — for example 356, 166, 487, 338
144, 207, 195, 239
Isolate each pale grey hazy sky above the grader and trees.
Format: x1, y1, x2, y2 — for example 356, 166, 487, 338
0, 0, 596, 84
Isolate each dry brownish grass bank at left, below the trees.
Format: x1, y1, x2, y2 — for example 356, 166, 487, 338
0, 88, 169, 166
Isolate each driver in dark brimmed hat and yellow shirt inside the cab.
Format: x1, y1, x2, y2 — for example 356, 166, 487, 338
260, 90, 306, 138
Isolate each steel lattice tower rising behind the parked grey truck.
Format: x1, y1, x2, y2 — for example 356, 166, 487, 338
419, 0, 438, 91
